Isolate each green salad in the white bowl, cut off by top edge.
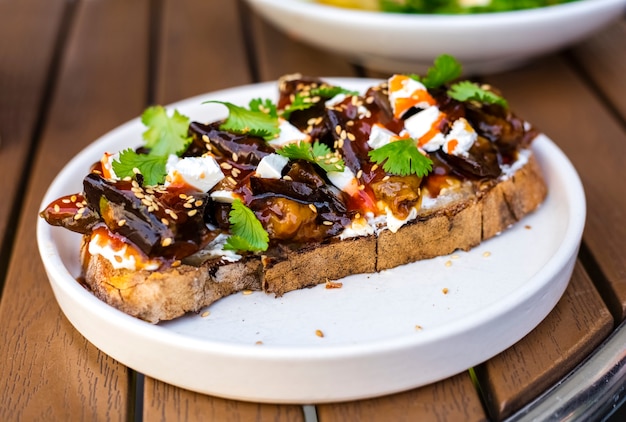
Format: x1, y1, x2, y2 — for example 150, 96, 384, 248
318, 0, 577, 14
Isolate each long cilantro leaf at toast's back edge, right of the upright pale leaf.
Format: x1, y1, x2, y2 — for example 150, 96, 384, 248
205, 101, 280, 140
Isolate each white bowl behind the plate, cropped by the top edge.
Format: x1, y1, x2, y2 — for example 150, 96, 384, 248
248, 0, 626, 74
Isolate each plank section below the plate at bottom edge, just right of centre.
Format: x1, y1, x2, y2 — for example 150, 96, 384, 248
317, 372, 487, 422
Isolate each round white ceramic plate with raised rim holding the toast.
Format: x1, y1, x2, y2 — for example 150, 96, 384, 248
37, 79, 585, 403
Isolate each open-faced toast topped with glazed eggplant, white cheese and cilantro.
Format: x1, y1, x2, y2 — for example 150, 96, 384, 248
41, 55, 546, 323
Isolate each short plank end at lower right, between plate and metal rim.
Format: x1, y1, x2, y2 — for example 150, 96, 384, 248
476, 263, 613, 420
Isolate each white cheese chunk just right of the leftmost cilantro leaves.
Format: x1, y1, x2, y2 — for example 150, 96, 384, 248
165, 155, 224, 192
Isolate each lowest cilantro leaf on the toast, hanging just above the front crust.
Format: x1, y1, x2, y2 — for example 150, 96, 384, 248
224, 199, 269, 252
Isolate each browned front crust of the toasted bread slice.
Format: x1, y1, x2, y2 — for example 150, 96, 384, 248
82, 155, 547, 323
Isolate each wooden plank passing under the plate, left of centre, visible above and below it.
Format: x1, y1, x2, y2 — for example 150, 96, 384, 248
143, 0, 303, 421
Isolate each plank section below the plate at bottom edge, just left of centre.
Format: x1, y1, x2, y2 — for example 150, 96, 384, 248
143, 378, 304, 422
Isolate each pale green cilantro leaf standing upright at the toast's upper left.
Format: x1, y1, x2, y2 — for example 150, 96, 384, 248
141, 106, 191, 156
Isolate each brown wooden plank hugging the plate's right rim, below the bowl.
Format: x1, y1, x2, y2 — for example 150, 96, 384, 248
488, 55, 626, 320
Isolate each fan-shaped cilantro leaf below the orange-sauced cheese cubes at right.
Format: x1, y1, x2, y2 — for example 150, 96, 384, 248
368, 139, 433, 177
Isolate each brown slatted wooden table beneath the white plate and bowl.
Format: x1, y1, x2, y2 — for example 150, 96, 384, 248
0, 0, 626, 422
